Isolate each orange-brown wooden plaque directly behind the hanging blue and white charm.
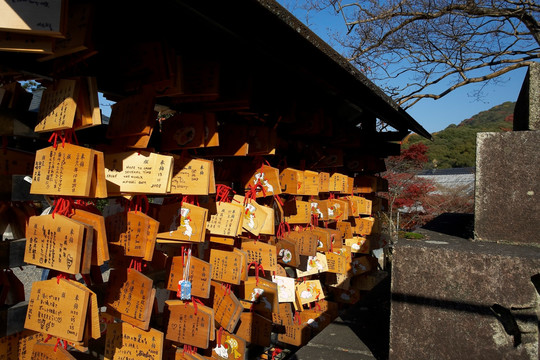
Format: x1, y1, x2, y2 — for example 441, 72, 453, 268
167, 256, 215, 298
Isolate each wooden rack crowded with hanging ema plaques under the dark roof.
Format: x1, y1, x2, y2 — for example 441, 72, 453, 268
0, 2, 387, 360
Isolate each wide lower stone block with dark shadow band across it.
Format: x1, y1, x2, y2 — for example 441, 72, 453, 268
390, 235, 540, 360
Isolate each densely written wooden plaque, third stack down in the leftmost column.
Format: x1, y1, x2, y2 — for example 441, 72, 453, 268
24, 214, 86, 274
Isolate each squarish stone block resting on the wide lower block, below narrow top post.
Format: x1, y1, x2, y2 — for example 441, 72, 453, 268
474, 131, 540, 246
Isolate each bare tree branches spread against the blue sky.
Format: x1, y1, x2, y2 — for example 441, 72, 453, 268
298, 0, 540, 108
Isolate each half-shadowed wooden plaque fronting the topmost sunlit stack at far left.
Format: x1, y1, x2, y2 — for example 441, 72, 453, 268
34, 79, 79, 133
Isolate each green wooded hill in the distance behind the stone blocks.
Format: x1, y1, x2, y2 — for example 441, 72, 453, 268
403, 101, 516, 169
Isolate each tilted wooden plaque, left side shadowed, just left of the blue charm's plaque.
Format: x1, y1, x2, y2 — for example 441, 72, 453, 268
105, 269, 153, 326
